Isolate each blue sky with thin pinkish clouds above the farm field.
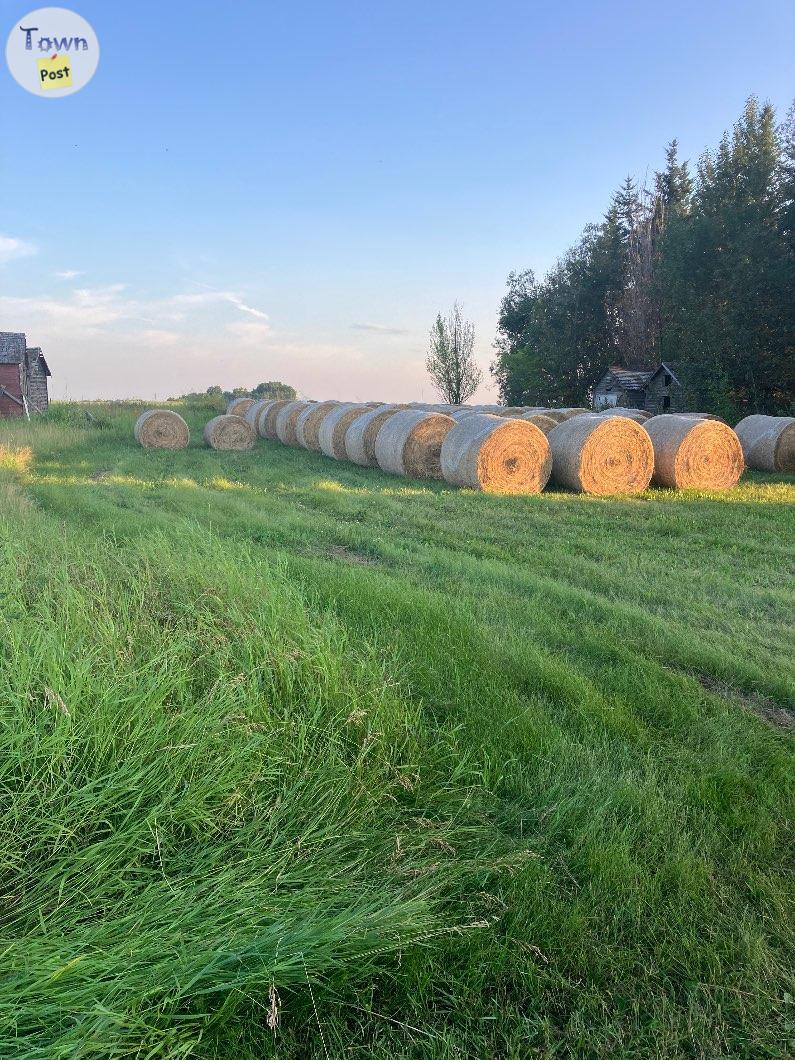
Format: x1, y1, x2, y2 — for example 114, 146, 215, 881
0, 0, 795, 400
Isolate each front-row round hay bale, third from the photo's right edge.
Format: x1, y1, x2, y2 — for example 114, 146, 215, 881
548, 416, 654, 497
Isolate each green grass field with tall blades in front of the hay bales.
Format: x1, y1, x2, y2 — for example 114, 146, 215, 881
0, 406, 795, 1060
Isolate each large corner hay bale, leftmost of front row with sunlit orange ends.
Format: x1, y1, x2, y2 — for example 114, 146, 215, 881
441, 413, 552, 493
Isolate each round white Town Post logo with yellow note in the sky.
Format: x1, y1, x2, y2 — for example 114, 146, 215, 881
5, 7, 100, 99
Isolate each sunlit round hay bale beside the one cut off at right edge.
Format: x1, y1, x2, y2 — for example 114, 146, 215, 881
643, 414, 744, 490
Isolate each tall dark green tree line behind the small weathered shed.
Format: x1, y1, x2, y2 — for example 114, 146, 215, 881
492, 98, 795, 419
